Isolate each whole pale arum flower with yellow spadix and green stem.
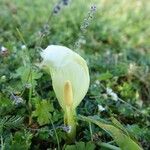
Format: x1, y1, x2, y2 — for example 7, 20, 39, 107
41, 45, 90, 140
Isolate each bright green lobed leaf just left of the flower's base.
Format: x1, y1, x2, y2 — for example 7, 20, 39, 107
32, 100, 54, 125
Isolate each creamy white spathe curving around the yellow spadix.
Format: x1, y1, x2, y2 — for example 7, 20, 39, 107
41, 45, 90, 110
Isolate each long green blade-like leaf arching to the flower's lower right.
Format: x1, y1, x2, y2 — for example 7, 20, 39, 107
80, 116, 142, 150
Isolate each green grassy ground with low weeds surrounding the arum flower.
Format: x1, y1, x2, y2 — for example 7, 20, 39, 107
0, 0, 150, 150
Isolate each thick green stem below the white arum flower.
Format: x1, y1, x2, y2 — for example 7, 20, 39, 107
64, 107, 76, 143
